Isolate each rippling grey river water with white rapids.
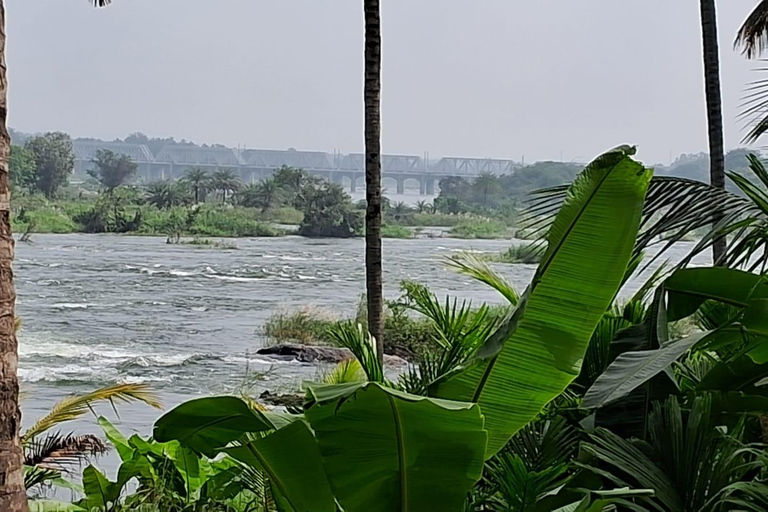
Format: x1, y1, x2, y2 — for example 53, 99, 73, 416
15, 235, 704, 480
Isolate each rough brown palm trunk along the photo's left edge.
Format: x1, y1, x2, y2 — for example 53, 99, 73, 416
0, 0, 27, 512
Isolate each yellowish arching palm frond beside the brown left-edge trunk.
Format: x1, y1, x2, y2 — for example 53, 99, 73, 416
21, 384, 162, 444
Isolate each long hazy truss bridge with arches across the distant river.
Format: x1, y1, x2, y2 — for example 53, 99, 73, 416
73, 141, 520, 195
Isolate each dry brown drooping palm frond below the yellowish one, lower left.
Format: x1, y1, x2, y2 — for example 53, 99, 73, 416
24, 432, 109, 471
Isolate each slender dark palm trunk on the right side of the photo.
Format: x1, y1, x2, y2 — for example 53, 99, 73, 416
700, 0, 726, 264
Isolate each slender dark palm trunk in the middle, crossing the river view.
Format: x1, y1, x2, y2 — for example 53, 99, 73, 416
363, 0, 384, 361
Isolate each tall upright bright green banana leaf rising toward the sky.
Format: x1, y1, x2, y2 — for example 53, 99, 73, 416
431, 147, 651, 457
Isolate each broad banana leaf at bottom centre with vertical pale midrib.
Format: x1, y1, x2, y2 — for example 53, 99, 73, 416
305, 383, 487, 512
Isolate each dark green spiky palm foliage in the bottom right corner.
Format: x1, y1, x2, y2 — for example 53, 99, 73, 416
584, 397, 768, 512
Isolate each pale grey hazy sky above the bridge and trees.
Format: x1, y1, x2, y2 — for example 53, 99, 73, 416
6, 0, 760, 163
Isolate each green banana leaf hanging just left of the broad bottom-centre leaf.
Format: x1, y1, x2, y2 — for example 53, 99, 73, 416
224, 421, 336, 512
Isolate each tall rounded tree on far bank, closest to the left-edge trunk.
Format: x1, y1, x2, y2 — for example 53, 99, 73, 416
24, 132, 75, 199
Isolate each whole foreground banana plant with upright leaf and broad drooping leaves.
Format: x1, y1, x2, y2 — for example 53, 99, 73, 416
153, 147, 651, 512
